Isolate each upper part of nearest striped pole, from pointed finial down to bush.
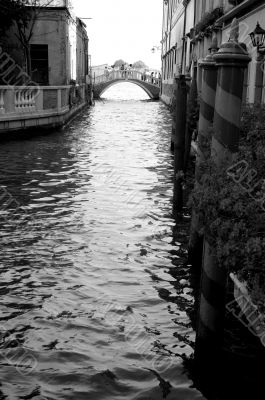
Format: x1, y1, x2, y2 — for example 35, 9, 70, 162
212, 18, 251, 165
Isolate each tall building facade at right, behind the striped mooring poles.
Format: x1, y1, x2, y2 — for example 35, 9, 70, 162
161, 0, 265, 104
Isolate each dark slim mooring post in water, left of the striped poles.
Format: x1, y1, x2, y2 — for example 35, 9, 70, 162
173, 75, 187, 214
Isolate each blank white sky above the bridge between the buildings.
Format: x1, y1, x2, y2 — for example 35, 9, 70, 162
72, 0, 163, 69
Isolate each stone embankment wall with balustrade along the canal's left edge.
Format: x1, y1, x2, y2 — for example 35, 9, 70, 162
0, 84, 91, 140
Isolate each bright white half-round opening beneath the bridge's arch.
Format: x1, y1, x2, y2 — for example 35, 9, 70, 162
102, 82, 150, 101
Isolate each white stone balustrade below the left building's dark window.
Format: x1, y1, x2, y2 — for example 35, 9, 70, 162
0, 85, 85, 116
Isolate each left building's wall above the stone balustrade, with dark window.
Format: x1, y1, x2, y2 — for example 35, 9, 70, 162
1, 0, 89, 86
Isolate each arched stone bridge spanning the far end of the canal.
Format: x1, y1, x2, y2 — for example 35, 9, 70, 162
93, 70, 160, 100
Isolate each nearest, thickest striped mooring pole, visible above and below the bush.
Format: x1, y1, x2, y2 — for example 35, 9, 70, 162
195, 19, 251, 368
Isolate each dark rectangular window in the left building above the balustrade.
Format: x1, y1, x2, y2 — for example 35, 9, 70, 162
30, 44, 49, 85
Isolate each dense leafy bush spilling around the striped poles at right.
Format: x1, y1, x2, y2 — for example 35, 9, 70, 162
191, 107, 265, 273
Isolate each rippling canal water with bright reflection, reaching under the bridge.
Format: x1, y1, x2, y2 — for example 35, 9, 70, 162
0, 84, 203, 400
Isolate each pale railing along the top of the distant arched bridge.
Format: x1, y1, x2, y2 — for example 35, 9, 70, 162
94, 69, 161, 86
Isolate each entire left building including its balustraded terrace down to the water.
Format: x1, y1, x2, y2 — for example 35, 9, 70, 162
0, 0, 89, 137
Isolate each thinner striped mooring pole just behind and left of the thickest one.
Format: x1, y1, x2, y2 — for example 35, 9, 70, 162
189, 33, 218, 267
